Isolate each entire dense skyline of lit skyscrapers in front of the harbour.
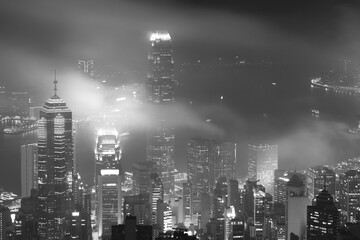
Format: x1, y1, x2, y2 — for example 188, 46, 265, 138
0, 32, 360, 240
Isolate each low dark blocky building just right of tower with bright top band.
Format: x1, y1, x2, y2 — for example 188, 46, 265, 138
124, 193, 151, 225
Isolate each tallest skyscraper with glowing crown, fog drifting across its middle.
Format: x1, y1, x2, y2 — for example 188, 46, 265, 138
146, 32, 175, 198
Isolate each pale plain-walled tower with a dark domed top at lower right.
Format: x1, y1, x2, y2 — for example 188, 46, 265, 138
285, 173, 310, 240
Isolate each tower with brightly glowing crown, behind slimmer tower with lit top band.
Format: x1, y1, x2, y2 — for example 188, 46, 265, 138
94, 129, 121, 186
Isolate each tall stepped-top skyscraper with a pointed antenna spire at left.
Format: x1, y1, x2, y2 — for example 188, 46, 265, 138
38, 80, 73, 239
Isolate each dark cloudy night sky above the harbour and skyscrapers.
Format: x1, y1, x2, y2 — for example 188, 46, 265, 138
0, 0, 360, 92
